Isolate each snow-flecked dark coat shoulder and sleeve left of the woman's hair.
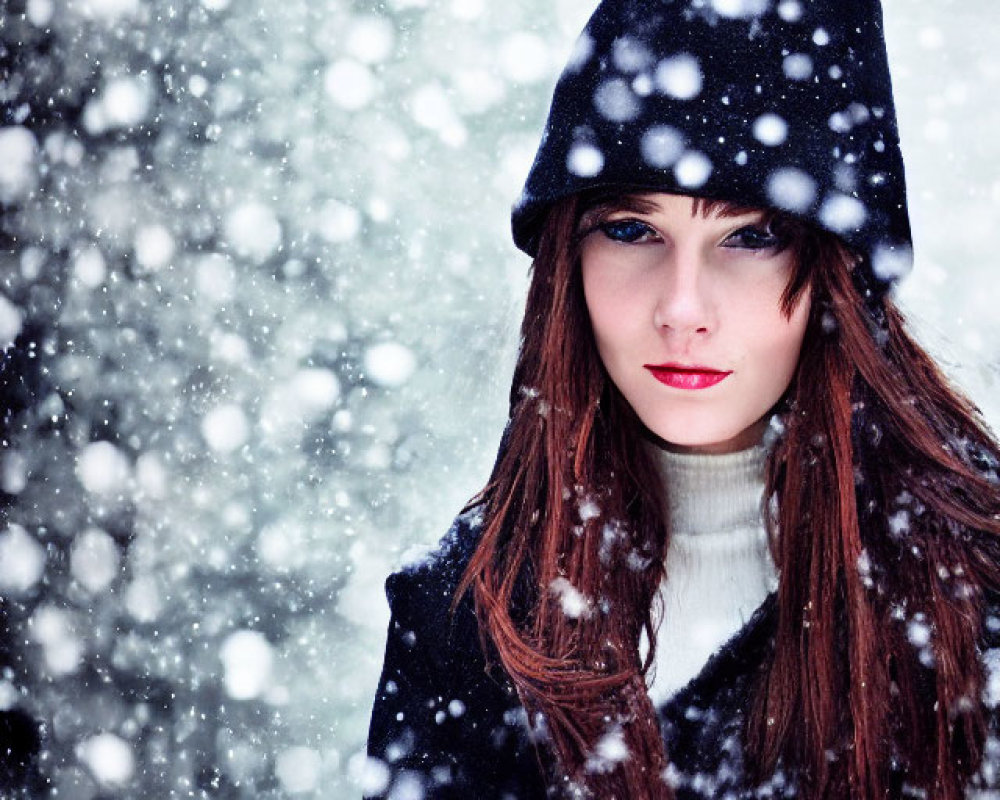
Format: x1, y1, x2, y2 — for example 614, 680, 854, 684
368, 510, 545, 800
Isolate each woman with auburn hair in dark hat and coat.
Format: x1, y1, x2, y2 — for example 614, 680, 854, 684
369, 0, 1000, 798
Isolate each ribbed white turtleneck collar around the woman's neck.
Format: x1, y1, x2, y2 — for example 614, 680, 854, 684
650, 445, 767, 535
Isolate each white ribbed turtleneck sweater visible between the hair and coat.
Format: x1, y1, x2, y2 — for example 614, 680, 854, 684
643, 446, 778, 705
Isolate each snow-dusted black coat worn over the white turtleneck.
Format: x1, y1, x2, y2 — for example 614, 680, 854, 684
368, 513, 1000, 800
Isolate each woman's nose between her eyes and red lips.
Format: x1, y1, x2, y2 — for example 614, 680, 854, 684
653, 242, 715, 335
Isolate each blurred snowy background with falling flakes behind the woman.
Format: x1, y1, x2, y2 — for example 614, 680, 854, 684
0, 0, 1000, 800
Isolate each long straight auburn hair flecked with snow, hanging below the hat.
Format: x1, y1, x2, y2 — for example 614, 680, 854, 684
455, 191, 1000, 800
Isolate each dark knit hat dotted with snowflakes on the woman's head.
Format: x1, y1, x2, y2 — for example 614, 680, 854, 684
512, 0, 912, 295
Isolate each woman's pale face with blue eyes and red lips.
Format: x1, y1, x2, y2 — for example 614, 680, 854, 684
581, 194, 809, 453
